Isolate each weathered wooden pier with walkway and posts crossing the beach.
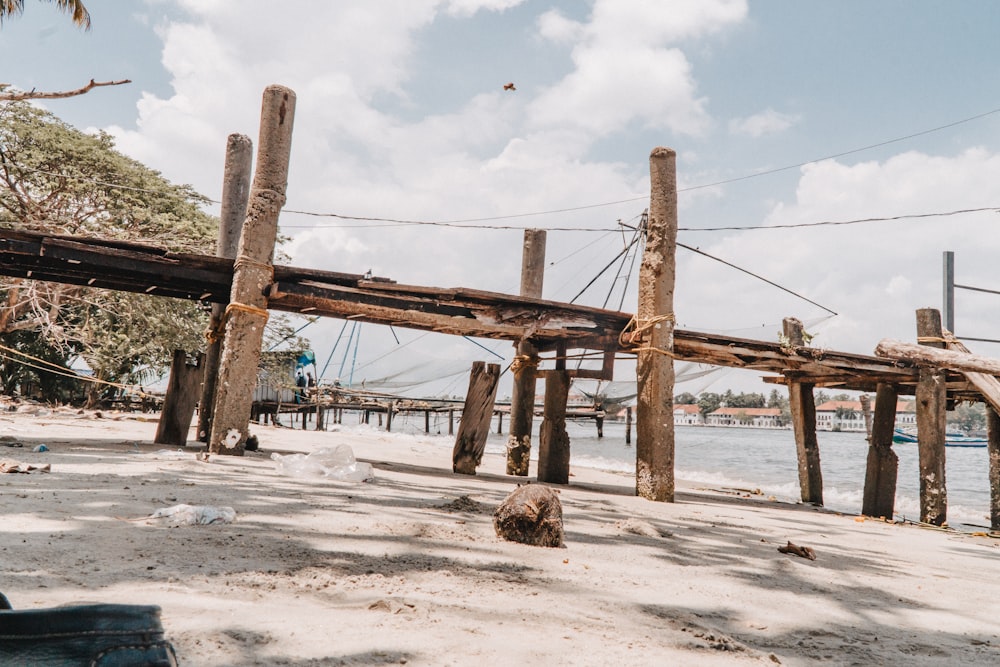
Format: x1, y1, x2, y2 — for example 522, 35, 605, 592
0, 86, 1000, 529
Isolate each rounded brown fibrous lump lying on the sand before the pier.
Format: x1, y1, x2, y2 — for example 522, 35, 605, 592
493, 484, 563, 547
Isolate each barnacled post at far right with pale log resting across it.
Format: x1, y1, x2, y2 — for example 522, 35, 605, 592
916, 308, 948, 526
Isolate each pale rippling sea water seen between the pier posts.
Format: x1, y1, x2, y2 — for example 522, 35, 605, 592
378, 415, 990, 527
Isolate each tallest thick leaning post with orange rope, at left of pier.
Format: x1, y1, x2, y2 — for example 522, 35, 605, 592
209, 86, 295, 456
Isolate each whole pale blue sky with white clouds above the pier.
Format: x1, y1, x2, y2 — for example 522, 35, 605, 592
0, 0, 1000, 391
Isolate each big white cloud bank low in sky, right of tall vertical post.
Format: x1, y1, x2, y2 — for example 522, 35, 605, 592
677, 149, 1000, 354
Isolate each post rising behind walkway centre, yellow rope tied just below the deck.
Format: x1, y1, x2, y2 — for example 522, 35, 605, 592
507, 229, 546, 477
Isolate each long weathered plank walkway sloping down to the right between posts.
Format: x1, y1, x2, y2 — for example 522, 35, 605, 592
0, 229, 928, 394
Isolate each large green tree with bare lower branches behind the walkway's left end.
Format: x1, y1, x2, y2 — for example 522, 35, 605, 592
0, 102, 218, 400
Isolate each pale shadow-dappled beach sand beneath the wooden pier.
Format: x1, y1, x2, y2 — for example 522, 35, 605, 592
0, 409, 1000, 666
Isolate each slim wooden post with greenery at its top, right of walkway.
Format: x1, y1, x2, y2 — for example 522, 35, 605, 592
782, 317, 823, 505
